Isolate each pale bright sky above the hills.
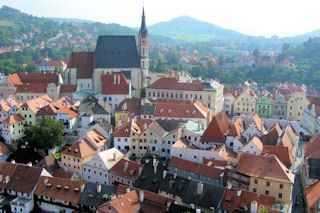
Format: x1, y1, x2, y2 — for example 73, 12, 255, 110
0, 0, 320, 37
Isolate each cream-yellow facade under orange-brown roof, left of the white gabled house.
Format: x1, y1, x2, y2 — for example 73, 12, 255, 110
61, 153, 94, 178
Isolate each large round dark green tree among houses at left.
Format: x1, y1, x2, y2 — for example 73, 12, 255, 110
24, 118, 64, 153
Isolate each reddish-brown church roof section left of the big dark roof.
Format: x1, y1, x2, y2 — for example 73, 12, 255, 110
68, 52, 94, 79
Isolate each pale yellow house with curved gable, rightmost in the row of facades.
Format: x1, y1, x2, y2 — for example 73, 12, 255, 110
287, 92, 309, 121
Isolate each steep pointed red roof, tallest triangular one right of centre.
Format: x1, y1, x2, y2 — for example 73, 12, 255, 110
201, 111, 230, 143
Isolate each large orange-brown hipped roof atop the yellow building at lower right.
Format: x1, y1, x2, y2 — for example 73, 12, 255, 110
236, 153, 294, 184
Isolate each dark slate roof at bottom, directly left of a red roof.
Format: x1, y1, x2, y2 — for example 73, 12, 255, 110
182, 180, 225, 209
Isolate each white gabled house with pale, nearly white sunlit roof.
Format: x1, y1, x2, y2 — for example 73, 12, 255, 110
82, 148, 125, 184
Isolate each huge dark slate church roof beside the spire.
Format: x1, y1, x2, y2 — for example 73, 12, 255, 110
94, 35, 140, 68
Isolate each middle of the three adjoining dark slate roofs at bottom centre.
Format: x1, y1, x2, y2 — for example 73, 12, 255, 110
159, 174, 189, 198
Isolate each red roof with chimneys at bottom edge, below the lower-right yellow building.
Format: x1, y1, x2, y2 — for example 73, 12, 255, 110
221, 188, 275, 212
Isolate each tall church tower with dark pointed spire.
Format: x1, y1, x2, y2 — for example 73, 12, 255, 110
138, 7, 149, 87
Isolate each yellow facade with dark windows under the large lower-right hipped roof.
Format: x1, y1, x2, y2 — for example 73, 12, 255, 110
249, 177, 292, 203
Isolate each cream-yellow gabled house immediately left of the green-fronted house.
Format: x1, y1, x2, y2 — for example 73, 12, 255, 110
233, 91, 256, 114
